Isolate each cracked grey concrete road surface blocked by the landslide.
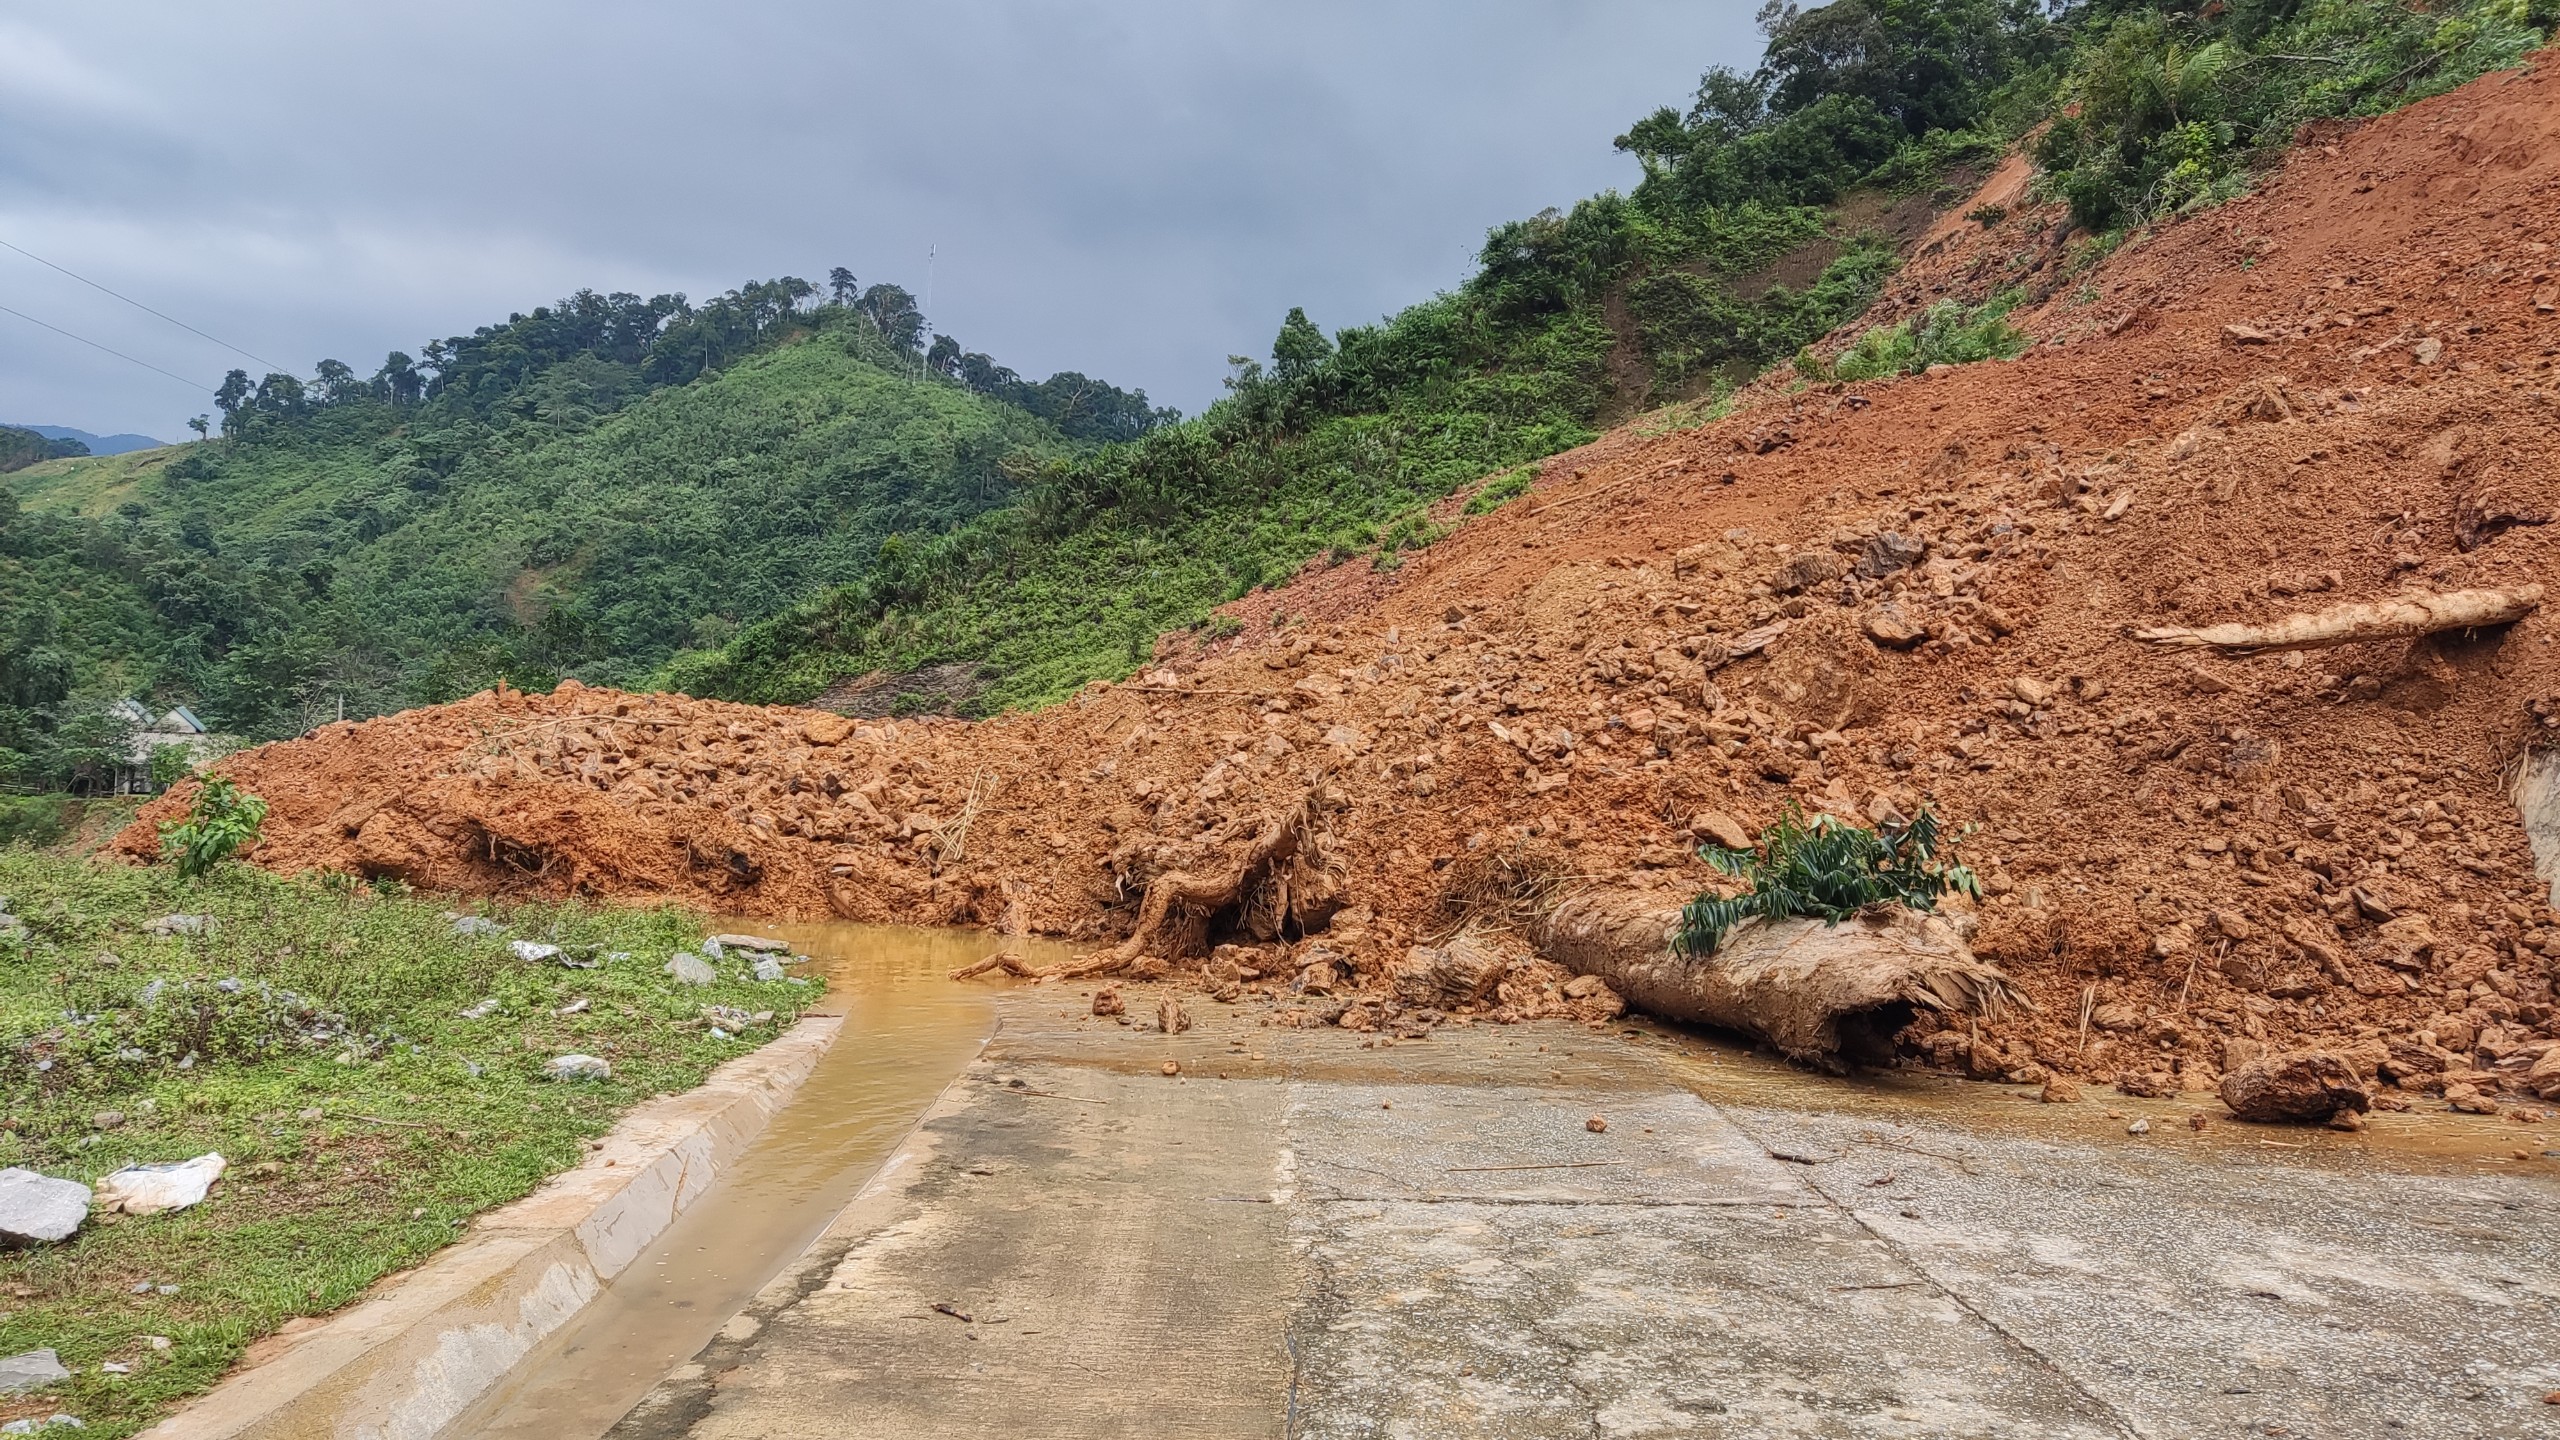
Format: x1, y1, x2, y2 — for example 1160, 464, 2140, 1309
593, 989, 2560, 1440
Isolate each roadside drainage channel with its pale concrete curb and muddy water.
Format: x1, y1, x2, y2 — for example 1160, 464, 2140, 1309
148, 925, 1064, 1440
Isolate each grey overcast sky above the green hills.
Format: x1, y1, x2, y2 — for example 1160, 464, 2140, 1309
0, 0, 1759, 438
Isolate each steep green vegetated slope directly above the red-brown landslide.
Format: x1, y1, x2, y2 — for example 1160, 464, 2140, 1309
666, 0, 2552, 712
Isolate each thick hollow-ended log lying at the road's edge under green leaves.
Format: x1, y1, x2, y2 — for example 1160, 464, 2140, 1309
1531, 889, 2028, 1068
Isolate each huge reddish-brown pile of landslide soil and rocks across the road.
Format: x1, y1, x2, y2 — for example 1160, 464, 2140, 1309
123, 56, 2560, 1107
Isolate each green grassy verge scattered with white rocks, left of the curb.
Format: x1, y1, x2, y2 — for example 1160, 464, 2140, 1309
0, 851, 817, 1437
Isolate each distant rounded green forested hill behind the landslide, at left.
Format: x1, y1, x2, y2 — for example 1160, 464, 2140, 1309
0, 272, 1170, 789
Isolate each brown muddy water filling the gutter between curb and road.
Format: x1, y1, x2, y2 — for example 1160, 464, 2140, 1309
443, 922, 1068, 1440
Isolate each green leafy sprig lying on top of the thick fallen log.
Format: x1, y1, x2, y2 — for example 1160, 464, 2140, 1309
1674, 805, 1981, 956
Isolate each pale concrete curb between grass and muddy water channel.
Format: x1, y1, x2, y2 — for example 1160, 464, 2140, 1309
146, 1015, 845, 1440
